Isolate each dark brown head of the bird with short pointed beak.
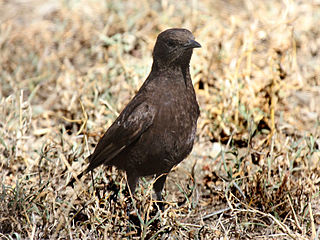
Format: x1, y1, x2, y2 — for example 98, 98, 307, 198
153, 28, 201, 68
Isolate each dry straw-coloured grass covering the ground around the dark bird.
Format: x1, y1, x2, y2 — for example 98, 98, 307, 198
0, 0, 320, 239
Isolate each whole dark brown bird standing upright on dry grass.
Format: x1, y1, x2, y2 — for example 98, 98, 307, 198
69, 28, 201, 201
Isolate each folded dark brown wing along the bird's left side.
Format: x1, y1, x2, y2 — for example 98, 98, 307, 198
85, 95, 156, 173
